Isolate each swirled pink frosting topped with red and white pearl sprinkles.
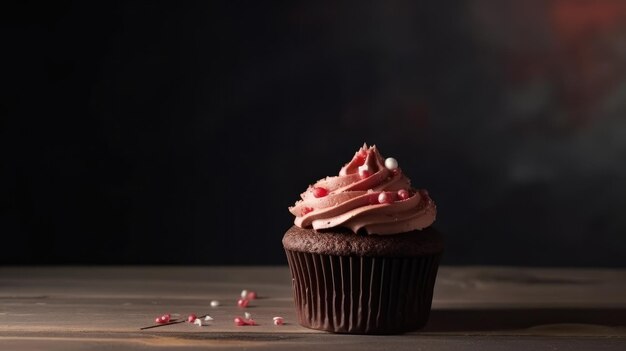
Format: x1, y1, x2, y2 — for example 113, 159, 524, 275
289, 144, 437, 235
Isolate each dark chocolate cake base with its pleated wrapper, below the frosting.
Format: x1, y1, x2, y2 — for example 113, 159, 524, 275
283, 227, 443, 334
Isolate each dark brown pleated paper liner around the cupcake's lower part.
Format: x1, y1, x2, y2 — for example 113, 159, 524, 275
285, 250, 441, 334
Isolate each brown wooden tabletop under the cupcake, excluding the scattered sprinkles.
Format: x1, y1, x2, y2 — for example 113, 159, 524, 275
0, 266, 626, 351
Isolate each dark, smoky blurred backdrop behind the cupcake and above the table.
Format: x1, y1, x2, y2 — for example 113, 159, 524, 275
0, 0, 626, 266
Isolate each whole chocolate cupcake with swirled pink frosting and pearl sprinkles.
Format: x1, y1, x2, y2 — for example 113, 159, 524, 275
283, 145, 443, 334
